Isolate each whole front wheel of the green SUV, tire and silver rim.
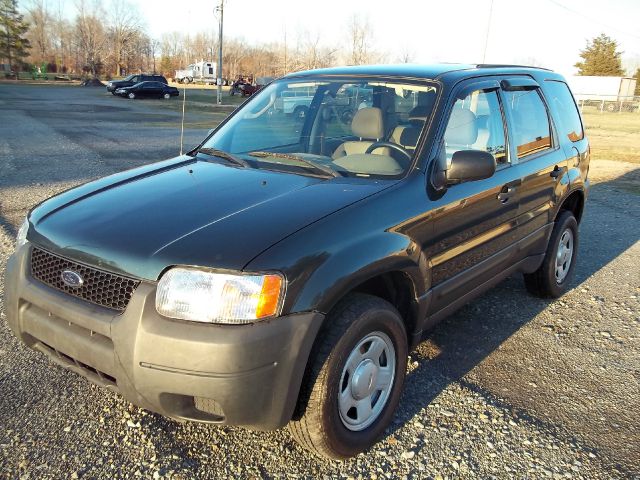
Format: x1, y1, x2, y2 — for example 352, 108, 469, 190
288, 294, 408, 459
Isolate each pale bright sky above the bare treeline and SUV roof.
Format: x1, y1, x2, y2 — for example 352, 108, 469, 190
55, 0, 640, 74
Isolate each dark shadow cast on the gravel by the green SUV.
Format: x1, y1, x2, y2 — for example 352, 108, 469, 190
385, 168, 640, 446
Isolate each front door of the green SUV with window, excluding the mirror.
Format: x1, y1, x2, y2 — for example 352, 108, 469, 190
425, 80, 520, 315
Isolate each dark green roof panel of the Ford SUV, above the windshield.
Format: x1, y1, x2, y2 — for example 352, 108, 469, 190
285, 63, 550, 79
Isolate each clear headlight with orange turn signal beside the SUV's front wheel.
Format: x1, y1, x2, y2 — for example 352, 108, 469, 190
156, 267, 284, 324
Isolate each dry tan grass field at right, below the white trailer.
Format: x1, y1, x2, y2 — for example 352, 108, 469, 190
582, 108, 640, 163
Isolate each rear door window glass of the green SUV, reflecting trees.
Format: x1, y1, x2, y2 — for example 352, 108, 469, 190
504, 88, 551, 158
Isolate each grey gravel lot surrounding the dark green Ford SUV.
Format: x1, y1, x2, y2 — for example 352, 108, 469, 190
0, 85, 640, 479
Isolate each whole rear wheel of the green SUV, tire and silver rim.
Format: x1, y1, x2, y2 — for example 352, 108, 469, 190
524, 210, 579, 298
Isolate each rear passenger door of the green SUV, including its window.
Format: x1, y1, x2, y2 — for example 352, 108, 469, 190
501, 77, 568, 253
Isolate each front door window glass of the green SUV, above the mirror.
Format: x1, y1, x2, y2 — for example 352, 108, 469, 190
444, 90, 509, 167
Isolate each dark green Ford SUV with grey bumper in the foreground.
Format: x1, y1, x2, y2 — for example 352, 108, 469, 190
5, 65, 589, 458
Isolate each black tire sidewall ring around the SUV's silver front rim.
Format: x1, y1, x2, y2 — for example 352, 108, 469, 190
322, 309, 408, 458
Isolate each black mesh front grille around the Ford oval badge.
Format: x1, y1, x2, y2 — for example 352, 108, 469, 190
31, 247, 140, 312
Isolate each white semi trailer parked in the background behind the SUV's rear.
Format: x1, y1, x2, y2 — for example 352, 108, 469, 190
567, 75, 640, 112
